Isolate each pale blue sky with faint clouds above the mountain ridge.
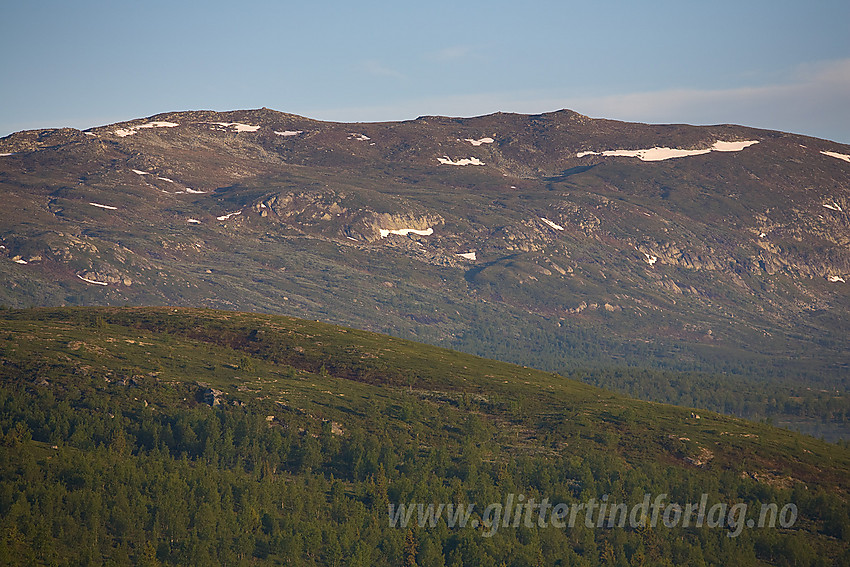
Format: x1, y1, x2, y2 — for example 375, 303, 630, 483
0, 0, 850, 143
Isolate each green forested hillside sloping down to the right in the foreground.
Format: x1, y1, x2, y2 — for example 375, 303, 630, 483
0, 307, 850, 567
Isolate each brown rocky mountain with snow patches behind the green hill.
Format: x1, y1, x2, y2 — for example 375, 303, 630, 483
0, 109, 850, 437
